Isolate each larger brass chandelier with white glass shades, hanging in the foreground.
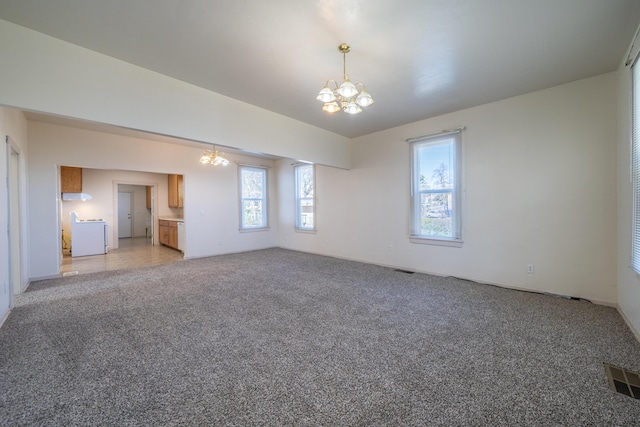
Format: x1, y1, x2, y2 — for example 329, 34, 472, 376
316, 43, 374, 114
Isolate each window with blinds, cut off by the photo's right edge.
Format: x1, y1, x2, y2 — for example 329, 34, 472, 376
631, 61, 640, 274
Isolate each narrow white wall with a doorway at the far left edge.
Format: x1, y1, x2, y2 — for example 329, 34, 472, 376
0, 107, 29, 324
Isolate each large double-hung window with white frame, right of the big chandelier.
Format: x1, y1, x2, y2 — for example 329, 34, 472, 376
410, 130, 462, 246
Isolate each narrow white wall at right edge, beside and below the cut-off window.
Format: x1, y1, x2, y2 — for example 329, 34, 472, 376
617, 52, 640, 340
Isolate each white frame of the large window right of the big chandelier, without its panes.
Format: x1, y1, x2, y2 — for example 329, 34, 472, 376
407, 128, 464, 247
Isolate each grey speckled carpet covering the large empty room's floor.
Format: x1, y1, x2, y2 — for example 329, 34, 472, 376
0, 249, 640, 426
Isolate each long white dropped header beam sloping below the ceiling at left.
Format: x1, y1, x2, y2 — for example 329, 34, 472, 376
0, 20, 350, 168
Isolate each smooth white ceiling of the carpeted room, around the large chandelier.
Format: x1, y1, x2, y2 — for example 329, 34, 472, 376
0, 0, 640, 137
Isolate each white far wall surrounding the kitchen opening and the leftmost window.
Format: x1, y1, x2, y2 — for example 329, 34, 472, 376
28, 121, 278, 280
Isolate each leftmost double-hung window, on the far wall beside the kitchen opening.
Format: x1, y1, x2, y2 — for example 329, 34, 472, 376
240, 166, 268, 230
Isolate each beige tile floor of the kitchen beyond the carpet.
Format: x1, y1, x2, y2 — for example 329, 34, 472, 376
60, 237, 184, 276
